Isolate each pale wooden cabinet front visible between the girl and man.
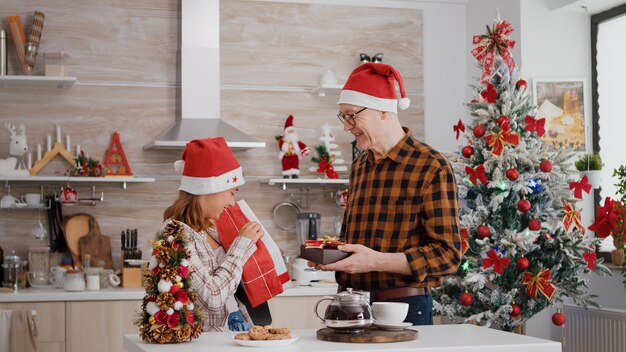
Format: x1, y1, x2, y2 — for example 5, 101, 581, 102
268, 296, 330, 329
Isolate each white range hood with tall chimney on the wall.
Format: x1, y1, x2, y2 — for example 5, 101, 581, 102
144, 0, 265, 150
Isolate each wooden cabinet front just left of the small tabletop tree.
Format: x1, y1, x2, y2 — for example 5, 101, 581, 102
65, 301, 141, 352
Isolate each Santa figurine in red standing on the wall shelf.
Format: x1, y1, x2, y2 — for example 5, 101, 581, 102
278, 115, 311, 178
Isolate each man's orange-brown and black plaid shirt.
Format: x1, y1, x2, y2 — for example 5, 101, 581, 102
337, 128, 461, 291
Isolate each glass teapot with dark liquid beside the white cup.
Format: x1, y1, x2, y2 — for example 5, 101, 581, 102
315, 288, 374, 333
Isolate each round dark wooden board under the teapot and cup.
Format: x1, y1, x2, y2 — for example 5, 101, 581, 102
317, 328, 419, 343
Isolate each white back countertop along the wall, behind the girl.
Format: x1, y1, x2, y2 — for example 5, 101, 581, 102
0, 285, 337, 303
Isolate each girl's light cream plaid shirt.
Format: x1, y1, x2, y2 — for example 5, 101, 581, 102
163, 219, 256, 331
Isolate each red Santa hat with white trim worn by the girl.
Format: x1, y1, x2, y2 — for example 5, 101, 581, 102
174, 137, 245, 195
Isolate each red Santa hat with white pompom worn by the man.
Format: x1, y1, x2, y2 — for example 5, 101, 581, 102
337, 62, 411, 113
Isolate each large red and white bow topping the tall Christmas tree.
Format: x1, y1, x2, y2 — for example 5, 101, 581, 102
472, 21, 515, 84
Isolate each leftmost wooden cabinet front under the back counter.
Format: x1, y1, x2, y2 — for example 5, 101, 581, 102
0, 302, 65, 352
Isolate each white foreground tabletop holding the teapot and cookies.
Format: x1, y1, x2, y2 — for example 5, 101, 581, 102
123, 325, 561, 352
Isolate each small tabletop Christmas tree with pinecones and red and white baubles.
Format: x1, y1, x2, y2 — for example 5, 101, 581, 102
135, 221, 202, 344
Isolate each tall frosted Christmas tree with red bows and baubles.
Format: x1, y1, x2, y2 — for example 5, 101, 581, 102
434, 16, 608, 331
